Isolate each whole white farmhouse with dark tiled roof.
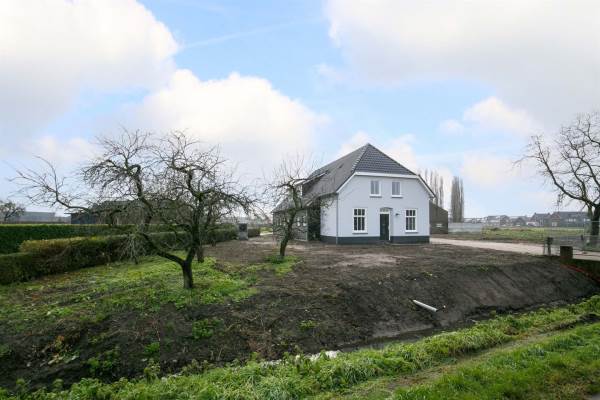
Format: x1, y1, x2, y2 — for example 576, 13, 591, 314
273, 144, 434, 244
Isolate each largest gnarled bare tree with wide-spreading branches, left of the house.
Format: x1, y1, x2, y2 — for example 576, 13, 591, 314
16, 131, 254, 288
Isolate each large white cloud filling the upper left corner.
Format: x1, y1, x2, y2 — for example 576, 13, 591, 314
0, 0, 177, 140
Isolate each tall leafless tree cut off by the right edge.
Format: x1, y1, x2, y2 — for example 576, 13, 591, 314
519, 112, 600, 240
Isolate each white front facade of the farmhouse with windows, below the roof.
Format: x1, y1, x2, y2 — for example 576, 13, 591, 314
321, 172, 432, 243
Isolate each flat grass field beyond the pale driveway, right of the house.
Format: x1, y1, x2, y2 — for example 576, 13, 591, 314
439, 227, 584, 244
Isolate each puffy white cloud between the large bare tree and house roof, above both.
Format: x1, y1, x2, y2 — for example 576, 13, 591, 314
123, 70, 326, 179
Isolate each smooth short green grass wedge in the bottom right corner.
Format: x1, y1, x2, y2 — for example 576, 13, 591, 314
393, 323, 600, 400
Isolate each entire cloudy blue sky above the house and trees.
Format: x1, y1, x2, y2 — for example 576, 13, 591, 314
0, 0, 600, 216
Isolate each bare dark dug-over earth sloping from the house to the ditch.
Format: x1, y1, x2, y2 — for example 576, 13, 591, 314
0, 236, 599, 387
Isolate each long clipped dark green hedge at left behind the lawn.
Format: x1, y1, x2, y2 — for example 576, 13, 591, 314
0, 227, 237, 284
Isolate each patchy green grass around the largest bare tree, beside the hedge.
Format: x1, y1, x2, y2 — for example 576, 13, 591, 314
0, 257, 256, 334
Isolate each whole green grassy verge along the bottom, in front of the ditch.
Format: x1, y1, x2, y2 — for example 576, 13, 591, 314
5, 296, 600, 399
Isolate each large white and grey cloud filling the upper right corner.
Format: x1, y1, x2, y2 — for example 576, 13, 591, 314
325, 0, 600, 124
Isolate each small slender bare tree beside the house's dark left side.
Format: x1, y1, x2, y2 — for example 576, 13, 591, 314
267, 155, 312, 259
